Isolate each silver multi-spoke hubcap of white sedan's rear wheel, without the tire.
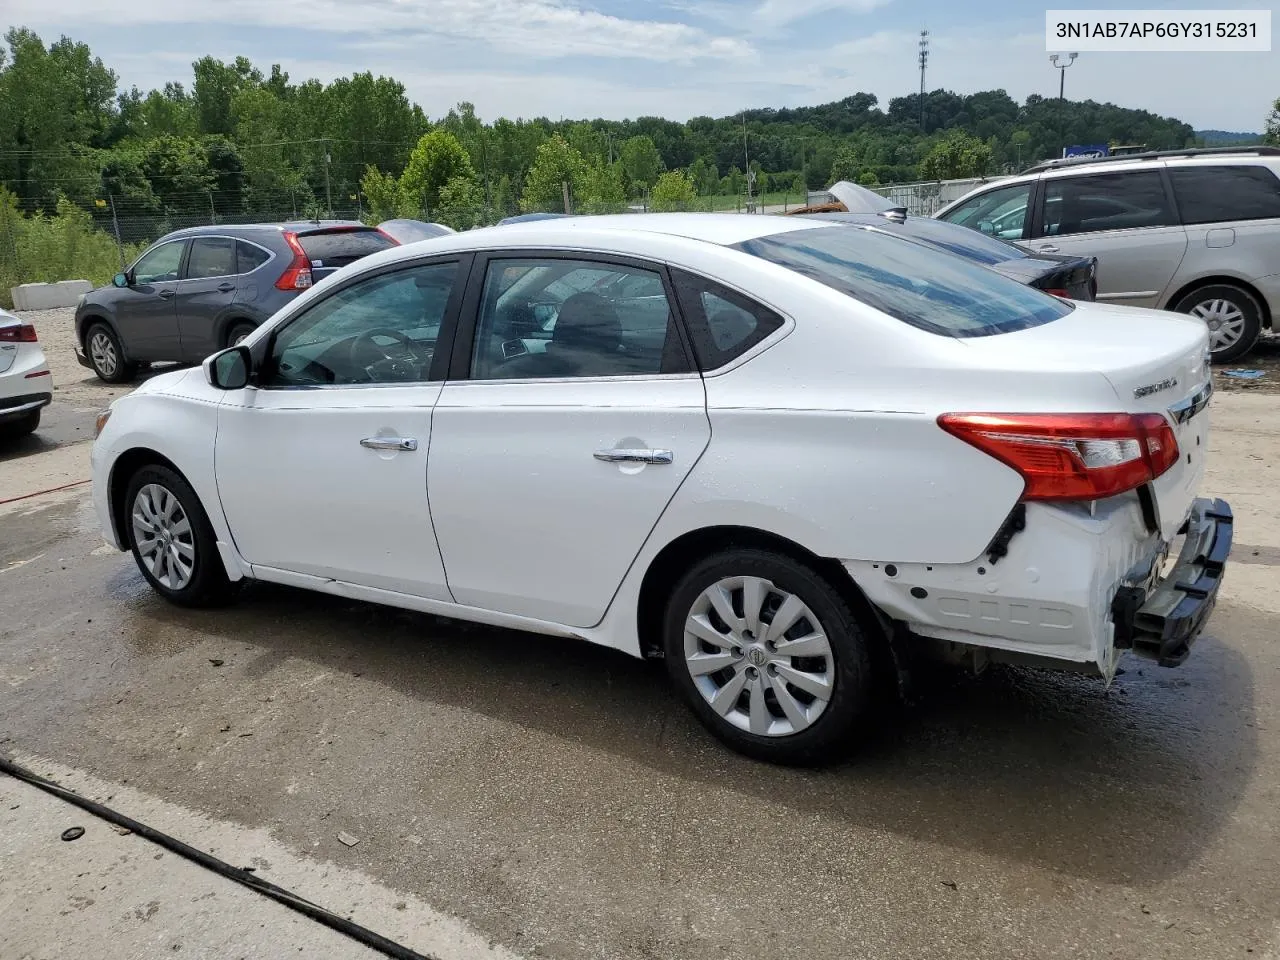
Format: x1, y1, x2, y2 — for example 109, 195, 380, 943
685, 577, 836, 737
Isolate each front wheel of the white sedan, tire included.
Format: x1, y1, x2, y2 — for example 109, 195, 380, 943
125, 463, 236, 607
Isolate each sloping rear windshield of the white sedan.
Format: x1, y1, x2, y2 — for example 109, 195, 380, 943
736, 227, 1073, 337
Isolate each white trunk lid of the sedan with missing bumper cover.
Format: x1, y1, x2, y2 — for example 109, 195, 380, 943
966, 303, 1212, 540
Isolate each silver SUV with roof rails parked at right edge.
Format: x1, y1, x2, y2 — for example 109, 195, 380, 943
937, 147, 1280, 362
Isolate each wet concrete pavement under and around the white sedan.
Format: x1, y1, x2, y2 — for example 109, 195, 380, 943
0, 314, 1280, 960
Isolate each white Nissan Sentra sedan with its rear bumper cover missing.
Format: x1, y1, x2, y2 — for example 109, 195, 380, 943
93, 214, 1231, 763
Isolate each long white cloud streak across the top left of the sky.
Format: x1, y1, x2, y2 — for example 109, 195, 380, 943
9, 0, 754, 63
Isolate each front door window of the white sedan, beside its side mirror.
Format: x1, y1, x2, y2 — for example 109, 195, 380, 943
262, 264, 457, 387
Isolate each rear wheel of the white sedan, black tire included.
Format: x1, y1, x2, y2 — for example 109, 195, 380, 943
663, 549, 872, 765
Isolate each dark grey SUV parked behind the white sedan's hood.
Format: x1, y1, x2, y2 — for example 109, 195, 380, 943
76, 220, 397, 383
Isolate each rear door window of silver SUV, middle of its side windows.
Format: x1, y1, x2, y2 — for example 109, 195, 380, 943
1043, 170, 1174, 237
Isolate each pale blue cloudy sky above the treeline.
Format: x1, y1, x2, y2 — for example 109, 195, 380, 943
3, 0, 1280, 131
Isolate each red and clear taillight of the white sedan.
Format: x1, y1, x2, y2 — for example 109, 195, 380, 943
938, 413, 1179, 500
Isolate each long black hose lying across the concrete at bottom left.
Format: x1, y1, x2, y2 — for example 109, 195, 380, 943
0, 756, 434, 960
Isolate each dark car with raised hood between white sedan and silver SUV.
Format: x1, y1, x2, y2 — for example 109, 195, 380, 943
792, 182, 1098, 300
